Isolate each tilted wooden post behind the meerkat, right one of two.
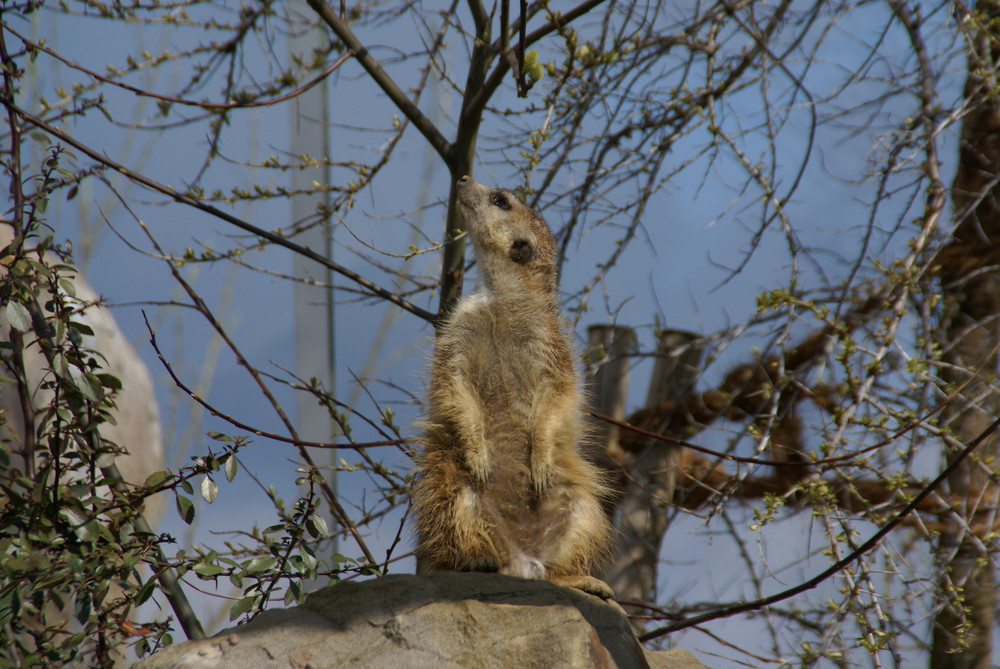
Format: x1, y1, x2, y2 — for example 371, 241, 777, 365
605, 330, 703, 626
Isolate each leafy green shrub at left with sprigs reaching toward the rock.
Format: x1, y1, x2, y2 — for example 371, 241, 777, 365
0, 162, 364, 666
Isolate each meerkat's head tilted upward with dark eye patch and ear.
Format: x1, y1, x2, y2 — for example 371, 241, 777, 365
457, 176, 556, 294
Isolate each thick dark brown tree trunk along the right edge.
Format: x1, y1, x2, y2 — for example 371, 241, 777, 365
916, 0, 1000, 669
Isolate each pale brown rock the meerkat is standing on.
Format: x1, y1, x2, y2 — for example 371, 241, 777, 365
136, 573, 706, 669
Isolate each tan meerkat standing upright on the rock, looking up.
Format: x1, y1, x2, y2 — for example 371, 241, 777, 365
412, 176, 613, 599
